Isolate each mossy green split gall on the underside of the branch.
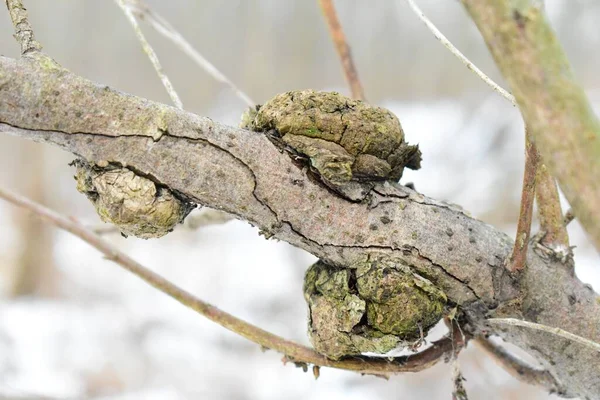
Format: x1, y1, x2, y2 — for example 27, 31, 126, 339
304, 258, 447, 359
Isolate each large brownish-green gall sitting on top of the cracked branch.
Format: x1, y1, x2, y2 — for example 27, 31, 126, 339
240, 90, 421, 198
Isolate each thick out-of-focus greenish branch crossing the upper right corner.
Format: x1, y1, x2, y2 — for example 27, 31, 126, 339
462, 0, 600, 250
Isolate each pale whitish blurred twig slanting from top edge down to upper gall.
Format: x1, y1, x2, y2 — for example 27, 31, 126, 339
126, 0, 256, 107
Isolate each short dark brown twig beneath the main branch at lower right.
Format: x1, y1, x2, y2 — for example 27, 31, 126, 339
475, 336, 561, 392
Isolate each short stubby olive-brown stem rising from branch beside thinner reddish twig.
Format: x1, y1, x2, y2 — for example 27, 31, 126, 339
535, 163, 569, 248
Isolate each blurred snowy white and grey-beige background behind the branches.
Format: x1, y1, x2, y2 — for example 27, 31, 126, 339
0, 0, 600, 400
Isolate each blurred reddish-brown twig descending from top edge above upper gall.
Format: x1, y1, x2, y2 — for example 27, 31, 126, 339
319, 0, 366, 101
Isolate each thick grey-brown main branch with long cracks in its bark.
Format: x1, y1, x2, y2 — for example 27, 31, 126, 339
0, 54, 600, 398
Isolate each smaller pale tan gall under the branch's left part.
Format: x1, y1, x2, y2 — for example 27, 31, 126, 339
73, 160, 194, 239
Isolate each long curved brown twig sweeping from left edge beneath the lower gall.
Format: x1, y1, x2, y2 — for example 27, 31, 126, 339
0, 188, 460, 375
